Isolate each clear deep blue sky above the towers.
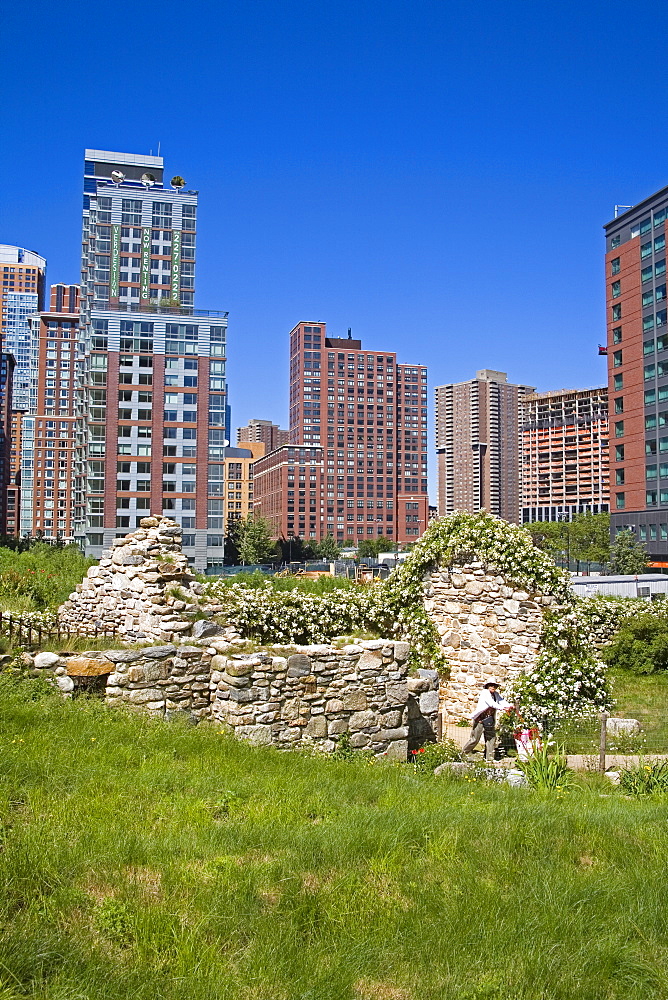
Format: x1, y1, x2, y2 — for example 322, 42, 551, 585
0, 0, 668, 498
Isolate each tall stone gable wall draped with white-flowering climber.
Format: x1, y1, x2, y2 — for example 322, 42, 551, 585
425, 562, 553, 722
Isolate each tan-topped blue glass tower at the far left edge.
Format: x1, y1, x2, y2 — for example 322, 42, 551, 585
0, 244, 46, 410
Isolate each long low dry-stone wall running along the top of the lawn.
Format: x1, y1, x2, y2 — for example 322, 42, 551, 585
32, 640, 438, 760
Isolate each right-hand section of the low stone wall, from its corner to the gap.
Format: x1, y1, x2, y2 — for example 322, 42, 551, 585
211, 639, 438, 760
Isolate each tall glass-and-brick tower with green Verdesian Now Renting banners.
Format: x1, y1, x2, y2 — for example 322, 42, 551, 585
75, 149, 229, 570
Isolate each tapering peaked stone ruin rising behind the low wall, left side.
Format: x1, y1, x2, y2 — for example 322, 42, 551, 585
58, 517, 217, 642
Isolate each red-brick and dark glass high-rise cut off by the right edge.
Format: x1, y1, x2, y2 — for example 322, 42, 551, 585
604, 187, 668, 566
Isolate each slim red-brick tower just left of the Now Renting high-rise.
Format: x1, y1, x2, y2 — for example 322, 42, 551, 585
20, 284, 79, 542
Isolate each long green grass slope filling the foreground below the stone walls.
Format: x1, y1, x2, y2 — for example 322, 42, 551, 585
0, 676, 668, 1000
